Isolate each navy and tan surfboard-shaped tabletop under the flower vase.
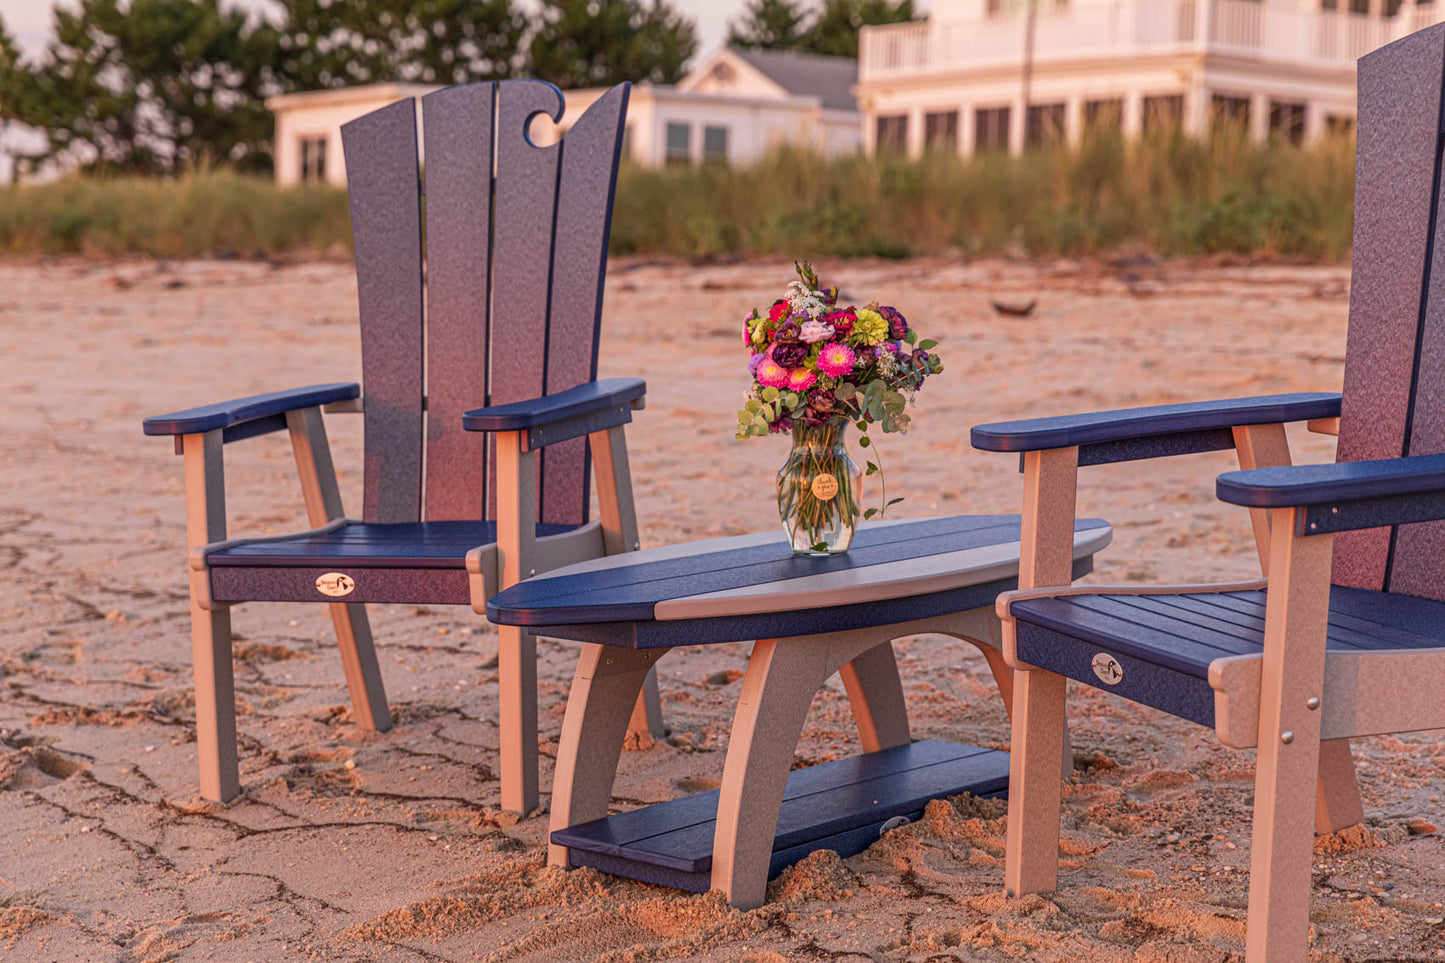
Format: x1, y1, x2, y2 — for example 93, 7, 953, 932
487, 515, 1111, 648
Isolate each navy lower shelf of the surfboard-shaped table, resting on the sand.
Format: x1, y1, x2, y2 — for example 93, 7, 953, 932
552, 742, 1009, 892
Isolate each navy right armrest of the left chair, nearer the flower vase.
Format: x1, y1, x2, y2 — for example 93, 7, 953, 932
461, 377, 647, 451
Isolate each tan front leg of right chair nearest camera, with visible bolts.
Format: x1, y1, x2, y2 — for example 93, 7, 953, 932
1246, 509, 1334, 963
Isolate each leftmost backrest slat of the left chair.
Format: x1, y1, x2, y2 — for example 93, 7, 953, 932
341, 98, 422, 522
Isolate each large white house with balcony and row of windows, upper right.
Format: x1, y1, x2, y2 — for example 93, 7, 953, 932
855, 0, 1445, 156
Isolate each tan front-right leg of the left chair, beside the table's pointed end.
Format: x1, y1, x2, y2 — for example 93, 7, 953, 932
497, 431, 539, 813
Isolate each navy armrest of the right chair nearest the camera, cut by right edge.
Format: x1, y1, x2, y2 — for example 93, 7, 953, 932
1215, 454, 1445, 535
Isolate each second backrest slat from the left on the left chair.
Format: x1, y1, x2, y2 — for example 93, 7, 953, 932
422, 84, 497, 521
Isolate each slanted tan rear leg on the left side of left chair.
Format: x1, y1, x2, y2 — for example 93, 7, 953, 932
286, 408, 392, 732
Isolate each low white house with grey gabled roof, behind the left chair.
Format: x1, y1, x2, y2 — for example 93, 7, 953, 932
266, 48, 863, 187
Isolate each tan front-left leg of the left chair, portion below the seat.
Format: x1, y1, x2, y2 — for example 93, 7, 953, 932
191, 602, 241, 803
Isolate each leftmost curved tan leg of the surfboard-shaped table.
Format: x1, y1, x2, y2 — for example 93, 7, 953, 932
548, 642, 667, 866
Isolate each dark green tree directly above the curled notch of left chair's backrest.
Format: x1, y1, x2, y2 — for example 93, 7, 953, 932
527, 0, 698, 88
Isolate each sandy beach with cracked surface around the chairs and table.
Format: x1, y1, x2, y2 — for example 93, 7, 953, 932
0, 259, 1445, 963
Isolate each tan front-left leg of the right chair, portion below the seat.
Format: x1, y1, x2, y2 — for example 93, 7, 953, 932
1004, 669, 1068, 896
